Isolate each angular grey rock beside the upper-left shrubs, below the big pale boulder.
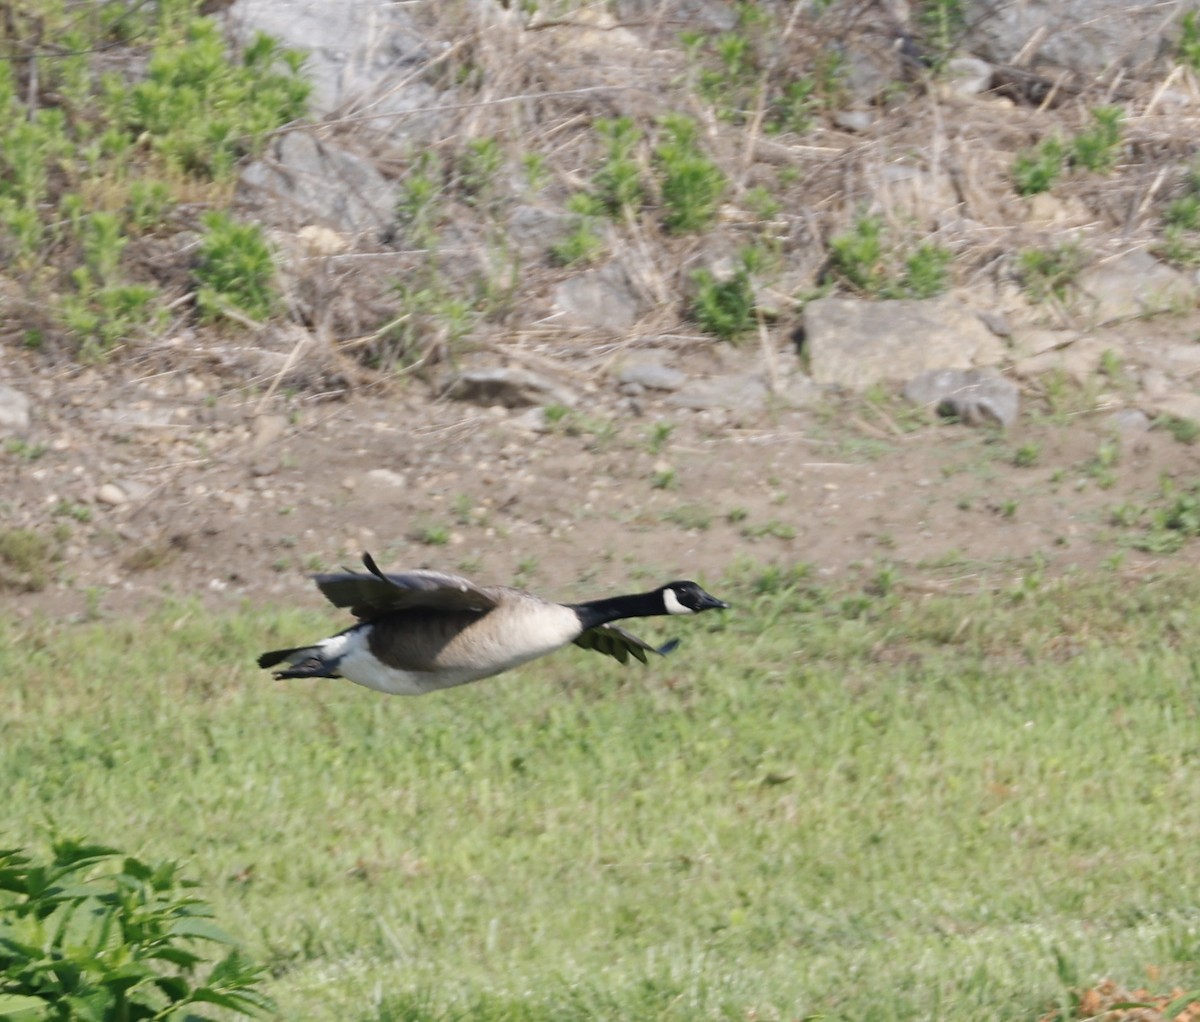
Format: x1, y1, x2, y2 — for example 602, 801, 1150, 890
239, 131, 396, 233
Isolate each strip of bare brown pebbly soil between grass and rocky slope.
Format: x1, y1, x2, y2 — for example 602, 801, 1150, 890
7, 319, 1200, 617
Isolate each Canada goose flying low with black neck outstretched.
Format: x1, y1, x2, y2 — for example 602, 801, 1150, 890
258, 553, 728, 696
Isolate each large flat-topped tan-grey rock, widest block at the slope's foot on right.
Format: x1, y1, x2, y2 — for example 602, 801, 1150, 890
804, 297, 1004, 390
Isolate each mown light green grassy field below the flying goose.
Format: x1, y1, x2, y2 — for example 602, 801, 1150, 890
0, 571, 1200, 1022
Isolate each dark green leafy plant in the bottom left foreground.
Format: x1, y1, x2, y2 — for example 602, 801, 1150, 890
0, 840, 275, 1022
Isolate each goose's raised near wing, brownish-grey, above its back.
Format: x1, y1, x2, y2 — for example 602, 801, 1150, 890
313, 553, 499, 620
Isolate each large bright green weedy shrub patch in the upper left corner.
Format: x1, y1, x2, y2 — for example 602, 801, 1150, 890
0, 0, 310, 360
